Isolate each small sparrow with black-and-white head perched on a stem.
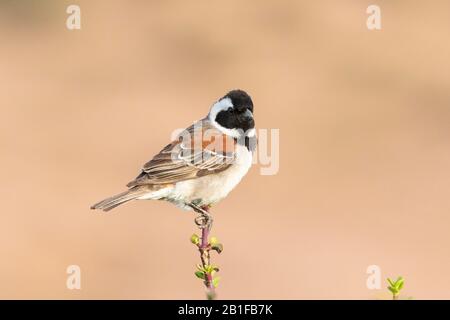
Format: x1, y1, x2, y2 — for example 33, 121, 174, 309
91, 90, 256, 227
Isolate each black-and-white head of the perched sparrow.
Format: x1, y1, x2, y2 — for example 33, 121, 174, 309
210, 90, 255, 133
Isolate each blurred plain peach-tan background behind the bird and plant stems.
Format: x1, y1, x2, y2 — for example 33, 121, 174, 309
0, 0, 450, 299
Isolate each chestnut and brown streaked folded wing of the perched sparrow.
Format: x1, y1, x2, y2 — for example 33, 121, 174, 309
127, 119, 236, 187
